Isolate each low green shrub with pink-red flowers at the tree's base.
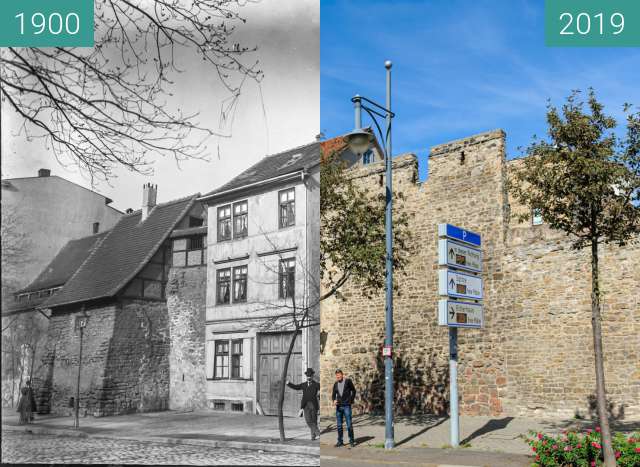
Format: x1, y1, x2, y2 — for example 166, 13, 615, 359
526, 427, 640, 467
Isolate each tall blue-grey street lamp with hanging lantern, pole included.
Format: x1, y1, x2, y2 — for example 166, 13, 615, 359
345, 60, 395, 449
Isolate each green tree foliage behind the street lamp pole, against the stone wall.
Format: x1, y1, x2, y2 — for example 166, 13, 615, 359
320, 145, 411, 301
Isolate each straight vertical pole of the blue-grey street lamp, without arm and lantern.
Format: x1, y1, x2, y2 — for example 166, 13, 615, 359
384, 60, 395, 449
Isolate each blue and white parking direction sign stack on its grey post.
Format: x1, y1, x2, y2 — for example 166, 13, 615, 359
438, 224, 484, 447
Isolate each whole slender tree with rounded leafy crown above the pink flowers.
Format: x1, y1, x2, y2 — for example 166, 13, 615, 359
511, 90, 640, 467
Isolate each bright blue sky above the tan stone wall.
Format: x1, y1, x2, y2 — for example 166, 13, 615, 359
320, 0, 640, 178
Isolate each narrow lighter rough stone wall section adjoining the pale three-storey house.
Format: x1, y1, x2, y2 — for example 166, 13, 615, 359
166, 266, 207, 410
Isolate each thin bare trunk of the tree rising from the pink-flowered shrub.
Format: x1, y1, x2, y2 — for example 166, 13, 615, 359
591, 239, 616, 467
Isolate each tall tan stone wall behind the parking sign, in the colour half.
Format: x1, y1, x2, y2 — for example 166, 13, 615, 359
321, 130, 640, 418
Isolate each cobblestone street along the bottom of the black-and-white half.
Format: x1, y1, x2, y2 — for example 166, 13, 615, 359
2, 431, 320, 465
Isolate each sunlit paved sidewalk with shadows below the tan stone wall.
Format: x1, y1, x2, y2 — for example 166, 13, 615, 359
320, 415, 640, 456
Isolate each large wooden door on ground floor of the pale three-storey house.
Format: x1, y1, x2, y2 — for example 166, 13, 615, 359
258, 332, 304, 417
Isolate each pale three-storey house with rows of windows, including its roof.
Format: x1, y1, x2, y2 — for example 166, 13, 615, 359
201, 143, 320, 415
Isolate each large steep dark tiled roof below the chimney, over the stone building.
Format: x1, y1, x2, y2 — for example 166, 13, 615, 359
43, 195, 197, 307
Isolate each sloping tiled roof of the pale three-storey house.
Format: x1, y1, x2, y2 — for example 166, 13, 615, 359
203, 142, 320, 197
